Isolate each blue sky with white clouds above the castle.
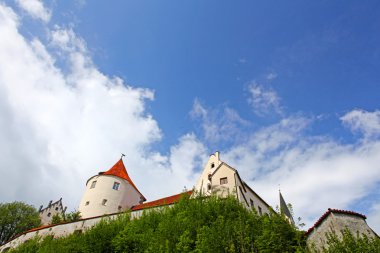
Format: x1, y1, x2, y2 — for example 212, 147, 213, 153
0, 0, 380, 233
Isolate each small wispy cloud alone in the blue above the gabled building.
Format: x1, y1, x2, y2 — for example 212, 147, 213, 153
248, 81, 282, 116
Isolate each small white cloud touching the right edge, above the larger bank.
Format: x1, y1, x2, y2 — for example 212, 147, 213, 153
340, 110, 380, 138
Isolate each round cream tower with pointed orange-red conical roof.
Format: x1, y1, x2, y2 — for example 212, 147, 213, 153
78, 158, 146, 219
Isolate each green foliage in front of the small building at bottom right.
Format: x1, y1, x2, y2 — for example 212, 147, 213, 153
324, 228, 380, 253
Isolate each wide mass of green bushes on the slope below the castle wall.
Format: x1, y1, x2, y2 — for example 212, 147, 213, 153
11, 197, 305, 253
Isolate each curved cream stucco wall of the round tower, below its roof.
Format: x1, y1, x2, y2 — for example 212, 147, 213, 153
78, 175, 141, 219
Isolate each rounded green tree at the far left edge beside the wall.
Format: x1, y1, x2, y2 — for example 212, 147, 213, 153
0, 202, 41, 244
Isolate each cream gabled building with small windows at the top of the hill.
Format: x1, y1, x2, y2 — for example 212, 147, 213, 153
194, 151, 271, 215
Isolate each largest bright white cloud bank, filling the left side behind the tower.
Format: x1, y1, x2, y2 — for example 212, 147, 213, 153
0, 1, 205, 211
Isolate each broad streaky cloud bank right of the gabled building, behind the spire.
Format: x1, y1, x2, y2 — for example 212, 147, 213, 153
222, 117, 380, 229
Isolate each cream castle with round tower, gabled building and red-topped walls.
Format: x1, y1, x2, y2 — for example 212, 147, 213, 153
0, 152, 377, 252
